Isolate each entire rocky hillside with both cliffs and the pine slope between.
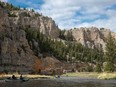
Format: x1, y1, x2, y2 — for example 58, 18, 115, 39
0, 2, 116, 73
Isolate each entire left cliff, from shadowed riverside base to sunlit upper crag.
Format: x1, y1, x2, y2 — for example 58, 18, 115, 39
0, 7, 59, 73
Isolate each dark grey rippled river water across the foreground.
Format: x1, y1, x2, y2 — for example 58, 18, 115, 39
0, 77, 116, 87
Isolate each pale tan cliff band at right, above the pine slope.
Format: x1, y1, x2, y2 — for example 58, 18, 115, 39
64, 27, 116, 49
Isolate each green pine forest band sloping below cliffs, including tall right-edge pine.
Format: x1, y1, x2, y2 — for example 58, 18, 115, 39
25, 28, 116, 72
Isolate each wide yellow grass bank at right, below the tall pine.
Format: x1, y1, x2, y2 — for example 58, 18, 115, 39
62, 72, 116, 79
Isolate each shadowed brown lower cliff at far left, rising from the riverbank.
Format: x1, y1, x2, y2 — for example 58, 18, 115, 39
0, 8, 36, 72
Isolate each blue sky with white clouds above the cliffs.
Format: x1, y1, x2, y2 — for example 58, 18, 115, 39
1, 0, 116, 32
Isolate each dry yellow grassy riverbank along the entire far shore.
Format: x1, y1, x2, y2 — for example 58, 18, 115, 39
0, 72, 116, 80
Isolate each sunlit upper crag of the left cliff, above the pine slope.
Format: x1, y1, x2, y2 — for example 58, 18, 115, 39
9, 10, 59, 38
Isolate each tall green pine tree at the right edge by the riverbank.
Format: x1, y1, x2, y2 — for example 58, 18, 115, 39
104, 33, 116, 72
